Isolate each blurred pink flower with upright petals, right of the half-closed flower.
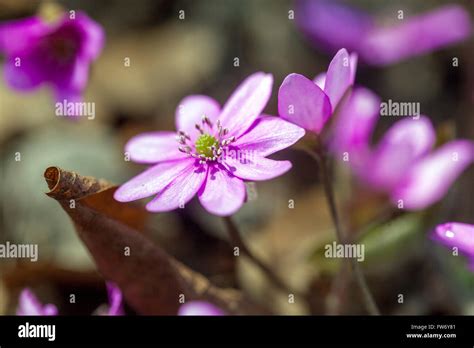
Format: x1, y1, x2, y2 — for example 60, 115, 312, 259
344, 113, 474, 210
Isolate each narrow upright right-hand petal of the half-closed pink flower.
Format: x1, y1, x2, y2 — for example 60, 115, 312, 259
324, 48, 355, 110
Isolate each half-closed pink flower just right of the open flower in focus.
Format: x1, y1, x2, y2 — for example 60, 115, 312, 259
278, 48, 357, 134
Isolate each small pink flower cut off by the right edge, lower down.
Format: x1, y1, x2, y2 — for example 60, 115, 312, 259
433, 222, 474, 272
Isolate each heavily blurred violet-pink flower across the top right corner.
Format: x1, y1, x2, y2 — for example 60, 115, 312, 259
296, 0, 471, 65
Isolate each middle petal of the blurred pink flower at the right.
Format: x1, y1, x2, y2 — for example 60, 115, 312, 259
363, 116, 435, 190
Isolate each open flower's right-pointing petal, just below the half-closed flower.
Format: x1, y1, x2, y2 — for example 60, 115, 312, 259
233, 116, 305, 157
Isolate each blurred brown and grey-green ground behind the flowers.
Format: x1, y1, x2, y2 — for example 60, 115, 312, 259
0, 0, 474, 315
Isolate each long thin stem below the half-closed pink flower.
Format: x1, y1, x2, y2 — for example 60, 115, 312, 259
311, 150, 380, 315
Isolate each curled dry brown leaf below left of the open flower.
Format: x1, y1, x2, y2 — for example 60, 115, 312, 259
44, 167, 266, 315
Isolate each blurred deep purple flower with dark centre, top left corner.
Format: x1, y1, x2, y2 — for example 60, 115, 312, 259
0, 13, 104, 102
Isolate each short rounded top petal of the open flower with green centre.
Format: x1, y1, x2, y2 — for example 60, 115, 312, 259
175, 95, 221, 140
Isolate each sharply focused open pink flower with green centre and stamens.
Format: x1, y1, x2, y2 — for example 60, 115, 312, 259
115, 72, 304, 216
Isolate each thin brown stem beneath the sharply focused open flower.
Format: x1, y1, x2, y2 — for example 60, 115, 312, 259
223, 216, 300, 298
